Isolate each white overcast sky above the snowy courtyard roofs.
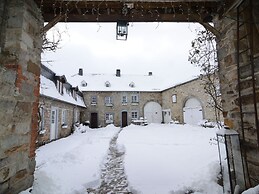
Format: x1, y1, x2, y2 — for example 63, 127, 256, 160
42, 23, 203, 83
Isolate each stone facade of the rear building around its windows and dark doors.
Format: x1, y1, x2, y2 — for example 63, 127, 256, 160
84, 92, 162, 126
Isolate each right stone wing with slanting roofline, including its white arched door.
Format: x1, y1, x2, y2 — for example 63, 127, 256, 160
162, 78, 219, 124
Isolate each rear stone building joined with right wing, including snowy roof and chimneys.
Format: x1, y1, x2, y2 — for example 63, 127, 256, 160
72, 69, 221, 128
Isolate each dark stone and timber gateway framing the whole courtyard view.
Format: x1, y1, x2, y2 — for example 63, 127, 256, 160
0, 0, 259, 194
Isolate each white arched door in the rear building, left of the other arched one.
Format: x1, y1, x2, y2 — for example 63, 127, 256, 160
144, 102, 162, 123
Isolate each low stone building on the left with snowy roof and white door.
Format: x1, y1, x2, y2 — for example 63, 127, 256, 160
37, 65, 86, 145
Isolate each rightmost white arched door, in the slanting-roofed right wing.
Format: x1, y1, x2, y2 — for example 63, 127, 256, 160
183, 97, 203, 125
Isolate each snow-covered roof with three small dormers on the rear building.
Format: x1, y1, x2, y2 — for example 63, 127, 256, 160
68, 74, 171, 92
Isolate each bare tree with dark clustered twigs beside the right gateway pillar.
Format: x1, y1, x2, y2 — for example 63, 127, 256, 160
188, 29, 222, 126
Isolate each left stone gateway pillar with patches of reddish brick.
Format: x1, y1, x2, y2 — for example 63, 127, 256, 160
0, 0, 43, 194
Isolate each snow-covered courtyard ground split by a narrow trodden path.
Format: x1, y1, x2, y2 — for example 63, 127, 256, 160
22, 124, 225, 194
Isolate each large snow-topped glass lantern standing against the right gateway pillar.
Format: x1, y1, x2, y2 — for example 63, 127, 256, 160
217, 129, 246, 194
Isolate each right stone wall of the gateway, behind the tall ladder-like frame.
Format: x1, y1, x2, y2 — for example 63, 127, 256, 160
214, 0, 259, 187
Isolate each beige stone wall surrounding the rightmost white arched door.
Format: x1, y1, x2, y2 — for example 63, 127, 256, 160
162, 79, 219, 123
